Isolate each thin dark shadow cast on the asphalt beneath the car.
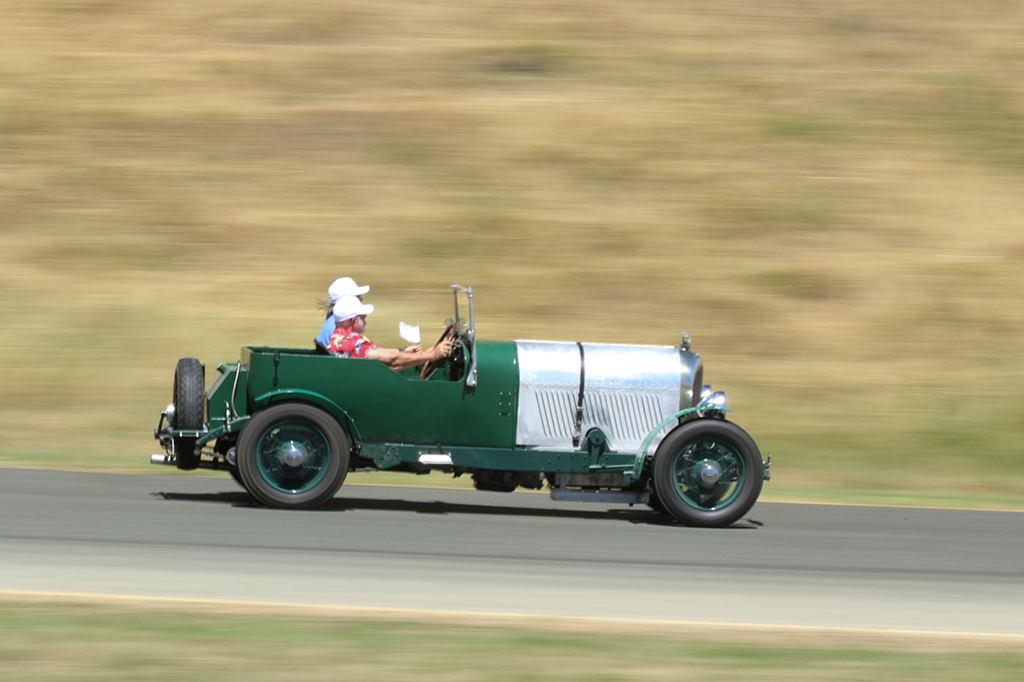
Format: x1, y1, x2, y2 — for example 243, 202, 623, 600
151, 491, 762, 529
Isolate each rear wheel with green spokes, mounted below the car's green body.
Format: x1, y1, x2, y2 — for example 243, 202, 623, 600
238, 402, 349, 509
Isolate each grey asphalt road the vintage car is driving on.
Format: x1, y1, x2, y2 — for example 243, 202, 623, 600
0, 469, 1024, 637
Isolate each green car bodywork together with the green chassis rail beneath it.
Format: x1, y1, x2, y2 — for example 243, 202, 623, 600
219, 341, 634, 473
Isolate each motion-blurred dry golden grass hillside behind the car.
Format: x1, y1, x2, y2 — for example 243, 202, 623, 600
0, 0, 1024, 498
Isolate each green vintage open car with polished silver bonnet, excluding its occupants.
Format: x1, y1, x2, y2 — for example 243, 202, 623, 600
152, 285, 771, 526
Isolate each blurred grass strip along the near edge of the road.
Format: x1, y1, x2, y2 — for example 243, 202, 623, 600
0, 601, 1024, 682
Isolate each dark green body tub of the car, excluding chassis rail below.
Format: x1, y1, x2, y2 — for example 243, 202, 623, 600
239, 341, 519, 452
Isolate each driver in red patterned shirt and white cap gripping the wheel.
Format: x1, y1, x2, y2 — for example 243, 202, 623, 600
327, 294, 452, 372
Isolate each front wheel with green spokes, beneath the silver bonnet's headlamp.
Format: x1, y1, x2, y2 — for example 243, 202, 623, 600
651, 419, 764, 527
